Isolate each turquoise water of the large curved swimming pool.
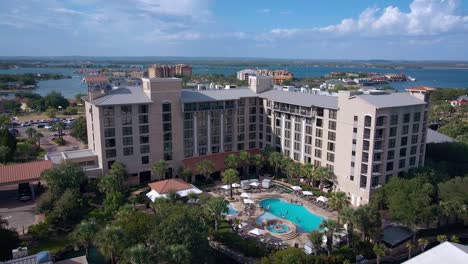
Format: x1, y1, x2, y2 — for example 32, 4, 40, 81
257, 199, 324, 233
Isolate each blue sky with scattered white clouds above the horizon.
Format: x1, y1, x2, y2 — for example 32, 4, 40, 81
0, 0, 468, 60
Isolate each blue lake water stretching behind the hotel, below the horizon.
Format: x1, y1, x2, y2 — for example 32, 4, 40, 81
0, 64, 468, 98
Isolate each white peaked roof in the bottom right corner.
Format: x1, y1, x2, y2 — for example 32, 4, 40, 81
403, 242, 468, 264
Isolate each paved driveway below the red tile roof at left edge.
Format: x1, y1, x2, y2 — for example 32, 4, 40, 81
0, 185, 37, 234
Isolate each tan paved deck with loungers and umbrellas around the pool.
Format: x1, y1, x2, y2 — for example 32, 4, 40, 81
210, 189, 338, 248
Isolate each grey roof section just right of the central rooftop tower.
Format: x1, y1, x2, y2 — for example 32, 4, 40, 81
259, 90, 338, 109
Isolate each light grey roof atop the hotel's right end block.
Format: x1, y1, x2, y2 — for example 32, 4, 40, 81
356, 93, 426, 108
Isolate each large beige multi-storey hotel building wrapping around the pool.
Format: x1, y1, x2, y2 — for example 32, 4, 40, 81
85, 76, 431, 205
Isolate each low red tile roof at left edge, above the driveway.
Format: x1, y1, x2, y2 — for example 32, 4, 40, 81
0, 160, 53, 184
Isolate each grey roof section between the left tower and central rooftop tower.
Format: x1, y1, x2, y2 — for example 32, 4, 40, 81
182, 88, 258, 103
